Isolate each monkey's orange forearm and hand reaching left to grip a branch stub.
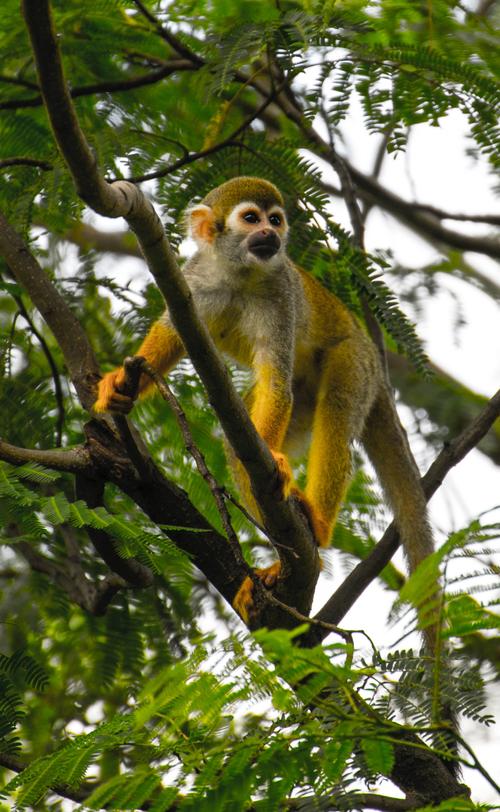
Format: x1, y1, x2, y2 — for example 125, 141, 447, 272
94, 321, 184, 414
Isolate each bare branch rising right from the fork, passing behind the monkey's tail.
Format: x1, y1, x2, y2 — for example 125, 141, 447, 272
301, 391, 500, 646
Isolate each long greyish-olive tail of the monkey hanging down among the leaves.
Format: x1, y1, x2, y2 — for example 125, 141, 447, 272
362, 386, 459, 776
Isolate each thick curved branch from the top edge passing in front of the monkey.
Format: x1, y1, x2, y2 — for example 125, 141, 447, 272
23, 0, 319, 622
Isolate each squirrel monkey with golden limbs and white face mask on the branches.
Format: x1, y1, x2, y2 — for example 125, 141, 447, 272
94, 177, 433, 619
